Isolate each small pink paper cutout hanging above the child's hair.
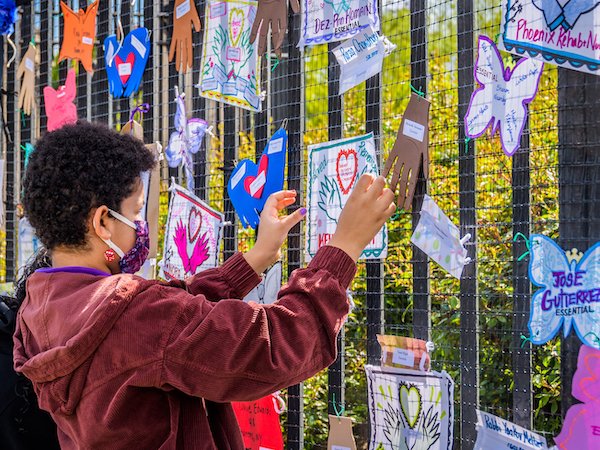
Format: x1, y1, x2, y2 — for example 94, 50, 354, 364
44, 69, 77, 131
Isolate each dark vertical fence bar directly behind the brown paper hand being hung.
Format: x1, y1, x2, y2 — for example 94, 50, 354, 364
410, 0, 431, 340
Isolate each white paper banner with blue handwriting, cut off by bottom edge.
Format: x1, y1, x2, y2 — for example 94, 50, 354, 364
473, 410, 548, 450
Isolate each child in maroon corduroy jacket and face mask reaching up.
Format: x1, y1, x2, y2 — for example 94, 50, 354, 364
14, 122, 395, 450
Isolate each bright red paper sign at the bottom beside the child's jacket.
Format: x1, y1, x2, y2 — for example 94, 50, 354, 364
232, 394, 285, 450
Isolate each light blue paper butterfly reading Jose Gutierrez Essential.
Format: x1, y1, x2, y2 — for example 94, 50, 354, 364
528, 234, 600, 349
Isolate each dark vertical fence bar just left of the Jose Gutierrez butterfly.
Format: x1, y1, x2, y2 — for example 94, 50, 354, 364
511, 120, 533, 430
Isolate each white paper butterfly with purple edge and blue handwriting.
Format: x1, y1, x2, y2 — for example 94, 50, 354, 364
465, 36, 544, 156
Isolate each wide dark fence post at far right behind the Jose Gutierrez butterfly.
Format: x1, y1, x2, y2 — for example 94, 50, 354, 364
558, 68, 600, 417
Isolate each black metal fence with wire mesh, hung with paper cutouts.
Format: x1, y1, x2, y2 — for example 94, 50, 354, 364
2, 0, 600, 449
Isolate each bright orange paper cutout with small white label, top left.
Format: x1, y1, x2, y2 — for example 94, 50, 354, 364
58, 0, 100, 73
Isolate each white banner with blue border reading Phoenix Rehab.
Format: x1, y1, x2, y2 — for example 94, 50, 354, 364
501, 0, 600, 74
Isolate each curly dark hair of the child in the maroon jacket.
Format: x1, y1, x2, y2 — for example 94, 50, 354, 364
23, 121, 155, 251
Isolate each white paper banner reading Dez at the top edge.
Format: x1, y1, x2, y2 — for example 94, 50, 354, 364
298, 0, 380, 47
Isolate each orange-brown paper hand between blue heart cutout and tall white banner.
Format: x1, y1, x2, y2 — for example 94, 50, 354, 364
169, 0, 200, 73
